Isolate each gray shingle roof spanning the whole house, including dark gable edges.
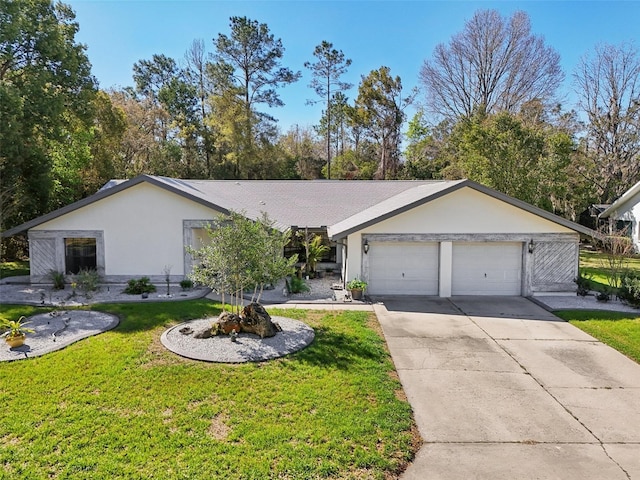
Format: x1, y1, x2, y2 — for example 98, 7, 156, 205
2, 175, 588, 238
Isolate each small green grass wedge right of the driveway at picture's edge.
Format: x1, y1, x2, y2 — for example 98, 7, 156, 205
553, 310, 640, 363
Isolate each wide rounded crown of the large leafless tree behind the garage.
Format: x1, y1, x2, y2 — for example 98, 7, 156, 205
420, 10, 564, 118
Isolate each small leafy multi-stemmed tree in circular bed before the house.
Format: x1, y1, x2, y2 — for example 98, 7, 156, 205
189, 212, 298, 314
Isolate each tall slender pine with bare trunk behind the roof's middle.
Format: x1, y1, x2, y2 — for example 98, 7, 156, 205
304, 40, 351, 179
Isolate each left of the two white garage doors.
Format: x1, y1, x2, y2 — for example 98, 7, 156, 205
367, 242, 438, 295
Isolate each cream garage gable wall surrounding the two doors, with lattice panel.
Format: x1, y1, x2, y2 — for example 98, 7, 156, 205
346, 188, 580, 297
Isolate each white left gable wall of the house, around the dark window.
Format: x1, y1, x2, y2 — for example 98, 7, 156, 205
29, 183, 216, 281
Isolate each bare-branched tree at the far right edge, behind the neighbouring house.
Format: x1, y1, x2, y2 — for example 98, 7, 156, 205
574, 44, 640, 203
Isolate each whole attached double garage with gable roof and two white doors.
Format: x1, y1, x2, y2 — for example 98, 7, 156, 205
328, 180, 590, 297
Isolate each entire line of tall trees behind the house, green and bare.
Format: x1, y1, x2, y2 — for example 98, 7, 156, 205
0, 0, 640, 237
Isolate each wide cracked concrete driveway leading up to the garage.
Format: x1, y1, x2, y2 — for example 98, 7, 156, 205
374, 297, 640, 480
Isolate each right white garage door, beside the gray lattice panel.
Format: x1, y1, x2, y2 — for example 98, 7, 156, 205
451, 242, 522, 295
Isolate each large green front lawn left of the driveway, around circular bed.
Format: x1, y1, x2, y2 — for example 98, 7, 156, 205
0, 300, 417, 479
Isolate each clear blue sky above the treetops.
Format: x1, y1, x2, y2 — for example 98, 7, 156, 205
64, 0, 640, 130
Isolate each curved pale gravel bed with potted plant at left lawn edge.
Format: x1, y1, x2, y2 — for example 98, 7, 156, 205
0, 310, 120, 361
